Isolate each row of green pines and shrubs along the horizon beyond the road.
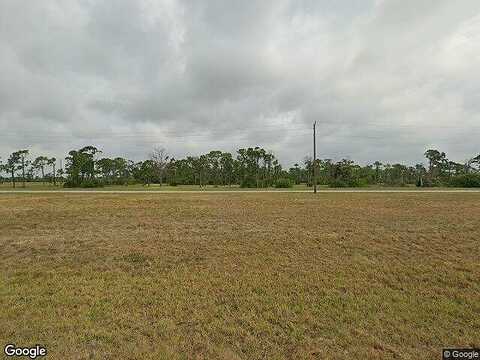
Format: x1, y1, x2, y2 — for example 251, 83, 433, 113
0, 146, 480, 188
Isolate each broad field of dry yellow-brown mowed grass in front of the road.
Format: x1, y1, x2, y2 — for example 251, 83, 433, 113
0, 193, 480, 359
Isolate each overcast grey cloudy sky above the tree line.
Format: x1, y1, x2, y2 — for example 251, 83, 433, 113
0, 0, 480, 166
